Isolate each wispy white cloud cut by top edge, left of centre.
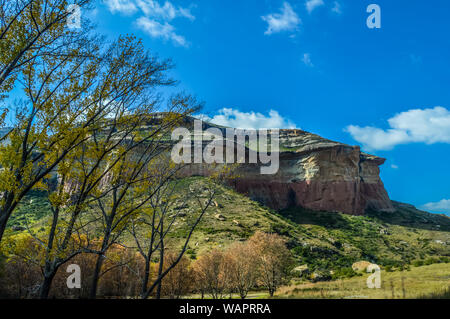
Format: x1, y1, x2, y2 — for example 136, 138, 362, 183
137, 0, 195, 21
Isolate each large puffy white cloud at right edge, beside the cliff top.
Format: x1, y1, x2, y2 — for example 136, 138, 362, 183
345, 106, 450, 150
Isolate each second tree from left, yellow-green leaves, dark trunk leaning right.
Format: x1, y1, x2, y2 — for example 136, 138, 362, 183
14, 37, 196, 298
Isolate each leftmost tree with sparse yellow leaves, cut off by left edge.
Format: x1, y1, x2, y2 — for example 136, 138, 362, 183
0, 0, 102, 241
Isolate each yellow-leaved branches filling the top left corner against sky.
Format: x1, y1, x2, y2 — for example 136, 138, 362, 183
0, 0, 95, 99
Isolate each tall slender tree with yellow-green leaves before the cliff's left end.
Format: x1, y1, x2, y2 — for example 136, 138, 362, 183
30, 37, 197, 298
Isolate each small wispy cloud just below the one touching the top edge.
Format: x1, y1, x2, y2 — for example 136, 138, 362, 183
136, 17, 189, 47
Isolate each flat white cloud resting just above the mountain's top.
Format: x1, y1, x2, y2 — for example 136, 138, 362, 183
200, 108, 296, 130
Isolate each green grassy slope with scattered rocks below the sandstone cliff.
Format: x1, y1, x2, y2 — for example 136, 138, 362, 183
4, 178, 450, 271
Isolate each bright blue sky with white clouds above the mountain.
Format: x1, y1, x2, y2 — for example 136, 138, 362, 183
71, 0, 450, 213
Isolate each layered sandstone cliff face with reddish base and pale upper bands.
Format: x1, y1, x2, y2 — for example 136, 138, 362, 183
181, 130, 394, 215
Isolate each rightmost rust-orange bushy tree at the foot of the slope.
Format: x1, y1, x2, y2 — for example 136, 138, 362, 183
249, 231, 292, 297
